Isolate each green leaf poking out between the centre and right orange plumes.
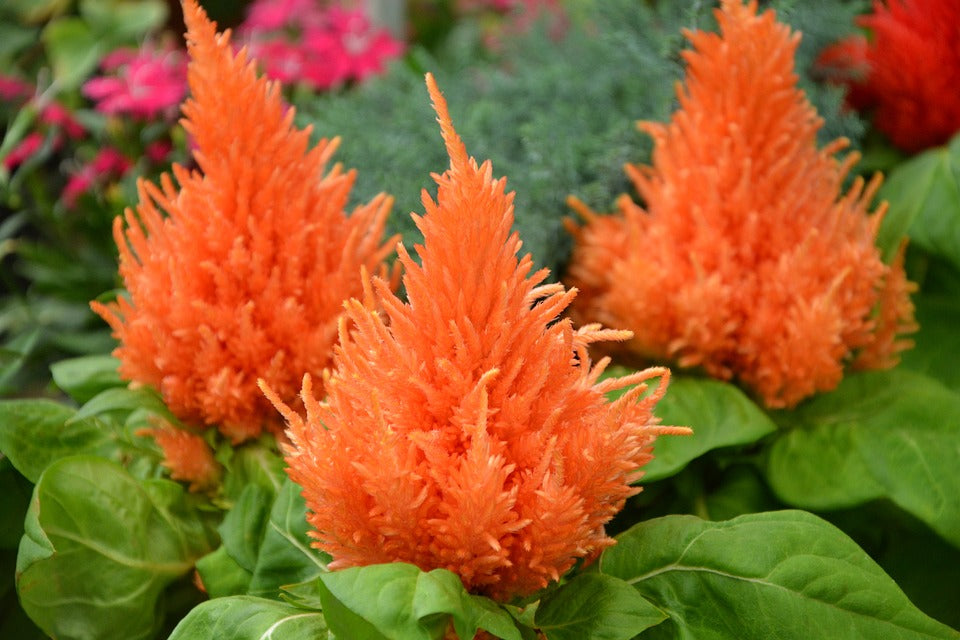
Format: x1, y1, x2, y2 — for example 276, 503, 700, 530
643, 377, 777, 482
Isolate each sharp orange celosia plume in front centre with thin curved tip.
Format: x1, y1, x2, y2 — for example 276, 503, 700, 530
265, 75, 688, 600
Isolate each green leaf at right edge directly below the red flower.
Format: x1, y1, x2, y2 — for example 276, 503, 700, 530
877, 136, 960, 266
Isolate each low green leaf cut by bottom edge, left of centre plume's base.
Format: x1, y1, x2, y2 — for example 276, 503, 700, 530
170, 596, 328, 640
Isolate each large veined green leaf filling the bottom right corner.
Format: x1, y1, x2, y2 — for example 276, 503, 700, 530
600, 511, 960, 640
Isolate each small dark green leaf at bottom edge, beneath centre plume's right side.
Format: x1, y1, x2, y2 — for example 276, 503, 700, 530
536, 573, 667, 640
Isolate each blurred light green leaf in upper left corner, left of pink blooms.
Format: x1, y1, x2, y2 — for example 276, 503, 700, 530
41, 18, 107, 91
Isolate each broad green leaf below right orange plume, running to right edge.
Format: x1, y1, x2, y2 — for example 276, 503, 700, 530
766, 369, 960, 546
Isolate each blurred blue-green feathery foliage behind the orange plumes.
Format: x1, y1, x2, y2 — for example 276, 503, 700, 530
296, 0, 863, 277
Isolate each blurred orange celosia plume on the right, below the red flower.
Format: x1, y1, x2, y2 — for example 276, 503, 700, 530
568, 0, 913, 407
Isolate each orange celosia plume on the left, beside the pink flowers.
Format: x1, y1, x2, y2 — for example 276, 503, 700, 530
92, 0, 393, 441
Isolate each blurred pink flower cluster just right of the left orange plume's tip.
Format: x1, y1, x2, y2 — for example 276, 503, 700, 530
244, 0, 403, 89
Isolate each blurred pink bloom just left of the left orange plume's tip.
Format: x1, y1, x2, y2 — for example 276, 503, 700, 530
83, 47, 187, 119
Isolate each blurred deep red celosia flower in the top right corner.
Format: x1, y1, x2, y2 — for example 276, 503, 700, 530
819, 0, 960, 152
